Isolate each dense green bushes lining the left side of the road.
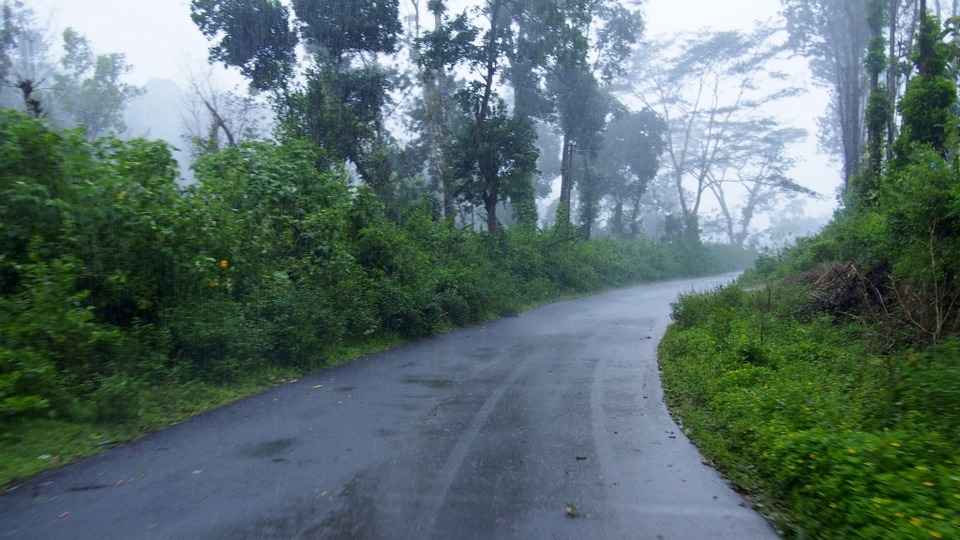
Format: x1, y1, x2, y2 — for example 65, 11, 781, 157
0, 111, 741, 434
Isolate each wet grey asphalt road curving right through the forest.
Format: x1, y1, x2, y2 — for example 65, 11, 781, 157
0, 278, 776, 540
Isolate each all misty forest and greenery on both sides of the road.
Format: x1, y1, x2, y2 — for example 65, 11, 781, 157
0, 0, 960, 538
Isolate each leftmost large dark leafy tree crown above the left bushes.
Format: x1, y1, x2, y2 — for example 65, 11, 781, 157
191, 0, 402, 191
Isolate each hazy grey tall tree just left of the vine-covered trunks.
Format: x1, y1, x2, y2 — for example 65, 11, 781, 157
782, 0, 872, 191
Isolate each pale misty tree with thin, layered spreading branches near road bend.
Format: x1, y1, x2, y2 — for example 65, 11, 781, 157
635, 27, 799, 244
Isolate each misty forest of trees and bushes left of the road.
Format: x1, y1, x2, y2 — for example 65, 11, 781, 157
0, 0, 772, 482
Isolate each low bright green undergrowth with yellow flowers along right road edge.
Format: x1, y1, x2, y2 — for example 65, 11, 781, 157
660, 286, 960, 539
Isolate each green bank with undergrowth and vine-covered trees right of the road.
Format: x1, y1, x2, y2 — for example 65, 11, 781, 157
660, 2, 960, 539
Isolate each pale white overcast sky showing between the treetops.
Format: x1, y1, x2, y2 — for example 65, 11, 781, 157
27, 0, 841, 216
